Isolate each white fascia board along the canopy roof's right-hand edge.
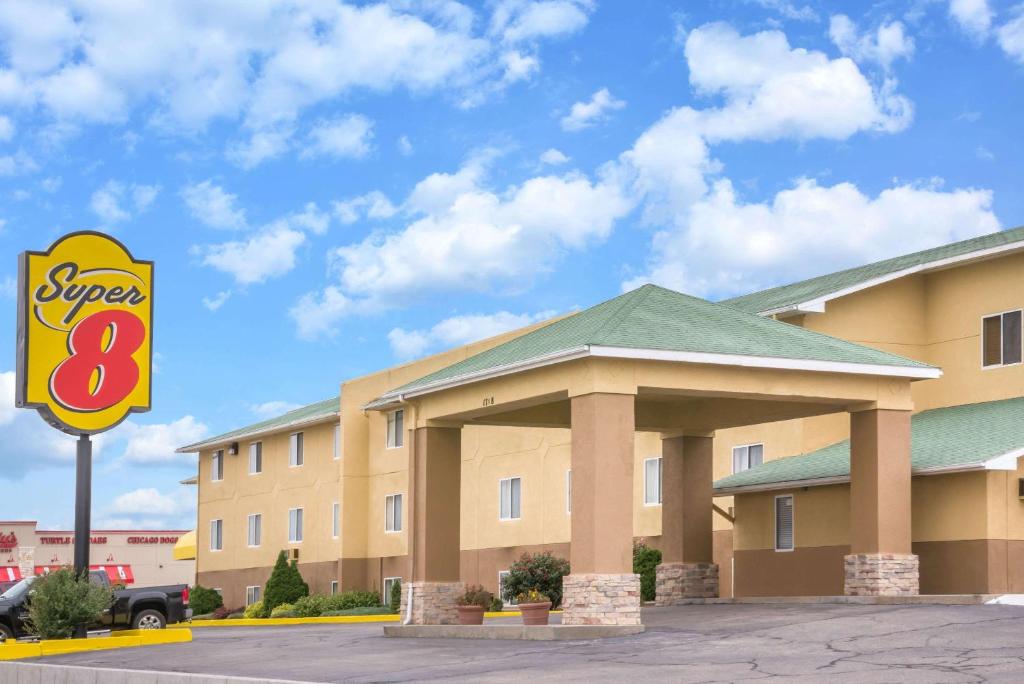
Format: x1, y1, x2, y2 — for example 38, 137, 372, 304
590, 345, 942, 379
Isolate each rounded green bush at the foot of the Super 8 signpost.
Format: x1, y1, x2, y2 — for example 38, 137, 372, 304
29, 567, 114, 639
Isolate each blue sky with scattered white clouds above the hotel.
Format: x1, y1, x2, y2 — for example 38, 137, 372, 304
0, 0, 1024, 527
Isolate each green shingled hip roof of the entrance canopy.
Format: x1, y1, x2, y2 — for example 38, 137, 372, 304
385, 285, 930, 397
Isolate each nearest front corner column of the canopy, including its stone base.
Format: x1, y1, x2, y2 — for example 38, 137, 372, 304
562, 392, 640, 625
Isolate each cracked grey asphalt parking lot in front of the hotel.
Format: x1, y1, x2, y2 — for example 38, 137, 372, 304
25, 605, 1024, 684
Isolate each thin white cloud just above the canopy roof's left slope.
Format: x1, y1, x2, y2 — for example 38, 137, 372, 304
387, 311, 555, 358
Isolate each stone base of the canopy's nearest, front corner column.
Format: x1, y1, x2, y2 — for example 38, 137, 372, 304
562, 572, 641, 625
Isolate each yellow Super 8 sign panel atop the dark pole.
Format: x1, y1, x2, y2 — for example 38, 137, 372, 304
15, 231, 153, 434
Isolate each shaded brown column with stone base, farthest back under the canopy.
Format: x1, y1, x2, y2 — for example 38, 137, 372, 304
655, 435, 718, 605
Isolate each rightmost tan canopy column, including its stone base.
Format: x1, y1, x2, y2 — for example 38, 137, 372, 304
845, 409, 920, 596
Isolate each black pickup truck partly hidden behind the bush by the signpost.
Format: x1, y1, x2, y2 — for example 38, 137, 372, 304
0, 570, 191, 639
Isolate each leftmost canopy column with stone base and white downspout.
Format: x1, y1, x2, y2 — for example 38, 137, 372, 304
401, 427, 464, 625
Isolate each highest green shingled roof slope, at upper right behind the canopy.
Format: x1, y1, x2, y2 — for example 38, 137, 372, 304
722, 227, 1024, 313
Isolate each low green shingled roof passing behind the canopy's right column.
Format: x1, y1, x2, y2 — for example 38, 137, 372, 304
715, 397, 1024, 489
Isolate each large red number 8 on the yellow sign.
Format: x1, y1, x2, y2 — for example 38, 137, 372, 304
50, 309, 145, 412
